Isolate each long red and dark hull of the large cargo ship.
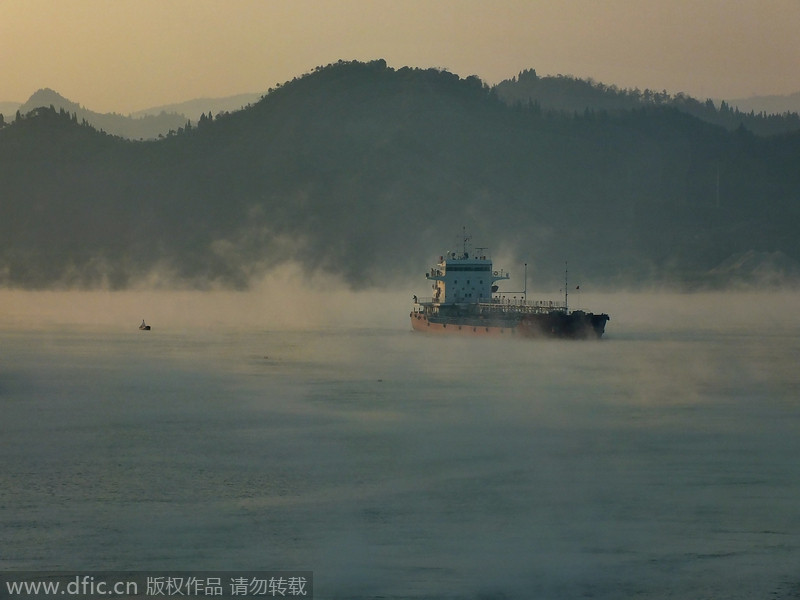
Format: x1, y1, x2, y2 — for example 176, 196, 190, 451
411, 311, 609, 339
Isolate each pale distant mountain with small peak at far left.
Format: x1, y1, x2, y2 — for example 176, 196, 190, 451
14, 88, 187, 140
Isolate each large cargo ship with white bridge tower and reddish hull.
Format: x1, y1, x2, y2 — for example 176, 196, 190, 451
410, 238, 610, 339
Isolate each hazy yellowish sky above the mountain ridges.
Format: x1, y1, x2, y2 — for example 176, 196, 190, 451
0, 0, 800, 114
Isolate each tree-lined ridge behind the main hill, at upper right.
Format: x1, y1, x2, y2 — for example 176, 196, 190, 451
495, 69, 800, 135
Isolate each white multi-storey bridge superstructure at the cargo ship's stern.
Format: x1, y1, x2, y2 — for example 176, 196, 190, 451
425, 250, 510, 304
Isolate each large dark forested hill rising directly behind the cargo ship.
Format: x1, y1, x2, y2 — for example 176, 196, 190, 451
0, 61, 800, 291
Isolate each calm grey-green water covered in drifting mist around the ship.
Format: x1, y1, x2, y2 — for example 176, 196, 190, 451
0, 292, 800, 599
